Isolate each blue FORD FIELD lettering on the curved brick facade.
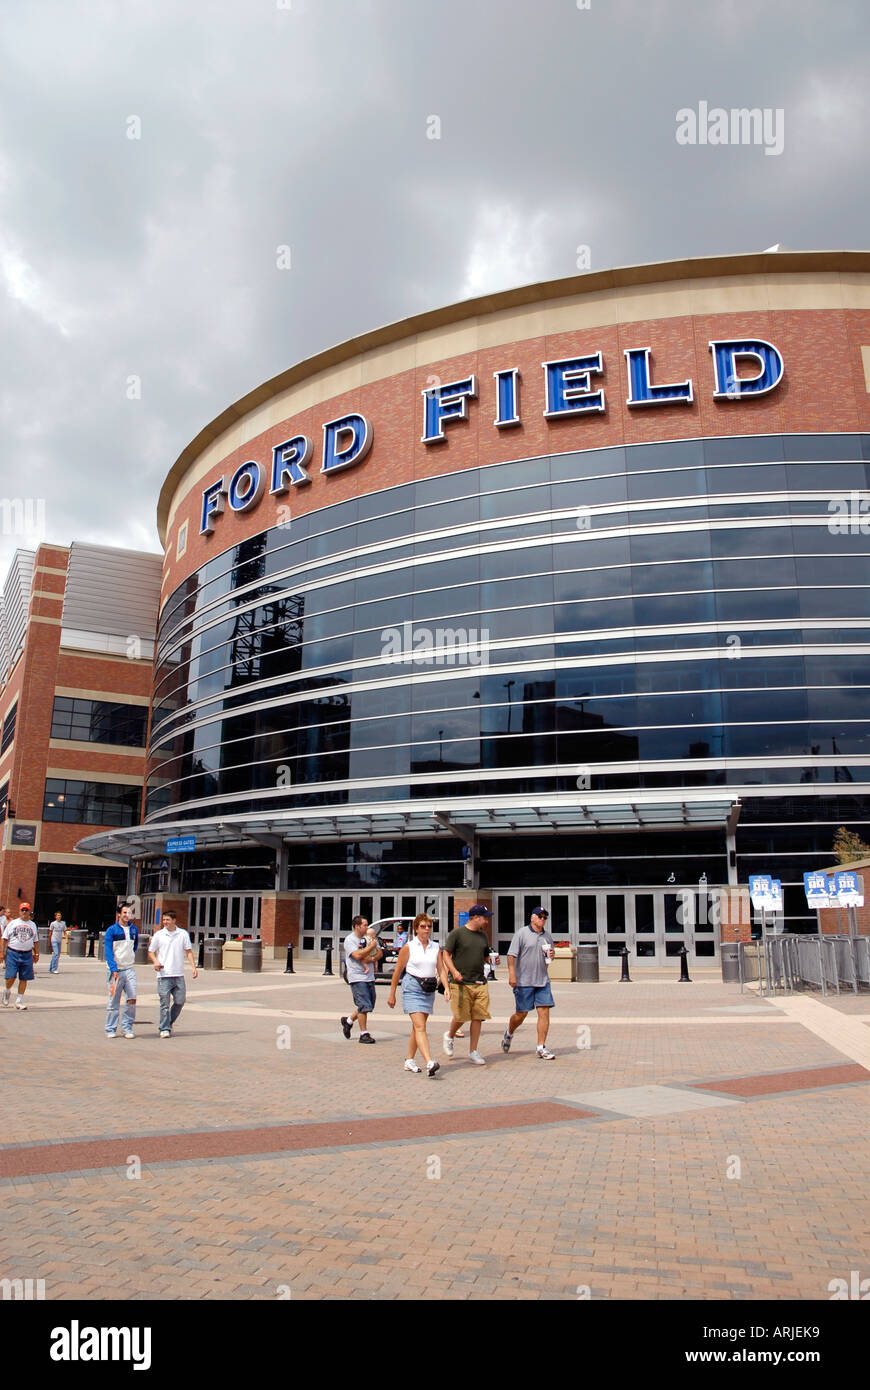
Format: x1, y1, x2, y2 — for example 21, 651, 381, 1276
200, 338, 785, 535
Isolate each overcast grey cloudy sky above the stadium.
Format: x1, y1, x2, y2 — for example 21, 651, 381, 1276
0, 0, 870, 584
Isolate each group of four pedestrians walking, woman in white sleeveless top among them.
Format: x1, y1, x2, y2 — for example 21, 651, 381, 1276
340, 904, 556, 1076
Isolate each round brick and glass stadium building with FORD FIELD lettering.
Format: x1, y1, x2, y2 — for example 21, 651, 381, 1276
79, 252, 870, 965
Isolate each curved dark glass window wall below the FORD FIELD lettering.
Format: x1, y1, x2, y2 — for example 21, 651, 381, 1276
147, 435, 870, 819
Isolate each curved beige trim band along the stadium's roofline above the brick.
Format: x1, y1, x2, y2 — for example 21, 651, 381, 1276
157, 252, 870, 545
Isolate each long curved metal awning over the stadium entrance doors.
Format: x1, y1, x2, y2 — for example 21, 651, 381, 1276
75, 788, 739, 862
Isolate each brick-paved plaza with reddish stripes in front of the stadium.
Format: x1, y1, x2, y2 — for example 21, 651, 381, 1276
0, 958, 870, 1300
